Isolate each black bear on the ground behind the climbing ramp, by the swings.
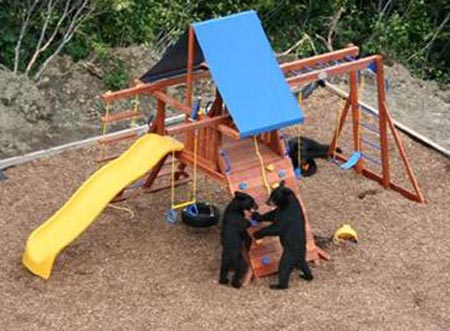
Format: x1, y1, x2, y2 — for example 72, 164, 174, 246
288, 137, 342, 177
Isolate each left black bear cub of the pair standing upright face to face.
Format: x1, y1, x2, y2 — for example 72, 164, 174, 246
219, 192, 258, 288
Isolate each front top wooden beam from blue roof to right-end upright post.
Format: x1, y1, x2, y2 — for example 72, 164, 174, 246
287, 55, 379, 87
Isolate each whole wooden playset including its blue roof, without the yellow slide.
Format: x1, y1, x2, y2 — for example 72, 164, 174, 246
21, 12, 425, 278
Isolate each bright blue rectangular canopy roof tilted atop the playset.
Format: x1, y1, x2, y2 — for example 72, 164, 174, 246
193, 11, 304, 137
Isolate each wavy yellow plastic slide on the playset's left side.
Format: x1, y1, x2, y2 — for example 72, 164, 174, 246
22, 134, 183, 279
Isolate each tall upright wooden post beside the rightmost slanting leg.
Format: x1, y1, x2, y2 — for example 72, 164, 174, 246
375, 56, 391, 187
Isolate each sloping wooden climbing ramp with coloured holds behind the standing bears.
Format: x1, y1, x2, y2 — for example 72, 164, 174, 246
222, 138, 328, 281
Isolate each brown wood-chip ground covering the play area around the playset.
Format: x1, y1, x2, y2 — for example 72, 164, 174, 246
0, 93, 450, 331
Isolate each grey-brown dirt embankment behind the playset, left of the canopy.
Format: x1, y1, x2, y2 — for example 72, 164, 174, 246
0, 46, 155, 159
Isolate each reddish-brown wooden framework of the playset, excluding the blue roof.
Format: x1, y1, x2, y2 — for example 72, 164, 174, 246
97, 39, 425, 286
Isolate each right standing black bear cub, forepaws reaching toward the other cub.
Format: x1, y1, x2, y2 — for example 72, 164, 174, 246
252, 181, 313, 289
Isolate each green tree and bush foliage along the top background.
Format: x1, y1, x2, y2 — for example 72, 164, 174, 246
0, 0, 450, 81
